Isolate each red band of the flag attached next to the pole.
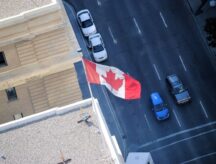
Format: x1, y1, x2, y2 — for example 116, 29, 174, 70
83, 59, 100, 84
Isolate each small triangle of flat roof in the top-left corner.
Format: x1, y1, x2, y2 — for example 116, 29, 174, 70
0, 0, 52, 19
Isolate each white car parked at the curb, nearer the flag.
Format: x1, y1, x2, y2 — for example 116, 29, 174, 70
89, 33, 107, 62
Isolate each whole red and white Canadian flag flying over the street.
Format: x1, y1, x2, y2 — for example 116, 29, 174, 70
83, 59, 141, 99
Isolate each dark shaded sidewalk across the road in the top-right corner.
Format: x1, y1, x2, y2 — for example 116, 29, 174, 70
187, 0, 216, 70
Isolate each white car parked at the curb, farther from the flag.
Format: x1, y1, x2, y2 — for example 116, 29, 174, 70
77, 9, 97, 37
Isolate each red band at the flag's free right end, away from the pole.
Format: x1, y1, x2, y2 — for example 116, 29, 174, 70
124, 74, 141, 99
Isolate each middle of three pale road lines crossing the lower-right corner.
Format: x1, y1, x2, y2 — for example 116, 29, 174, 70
150, 129, 216, 152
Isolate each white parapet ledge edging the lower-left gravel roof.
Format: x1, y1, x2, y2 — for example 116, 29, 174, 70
0, 98, 124, 164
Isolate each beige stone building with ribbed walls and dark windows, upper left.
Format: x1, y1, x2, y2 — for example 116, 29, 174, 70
0, 0, 82, 123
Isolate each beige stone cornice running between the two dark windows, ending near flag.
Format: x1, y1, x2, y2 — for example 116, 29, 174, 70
0, 52, 82, 90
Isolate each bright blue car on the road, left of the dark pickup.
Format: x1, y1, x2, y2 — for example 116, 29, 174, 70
150, 92, 169, 120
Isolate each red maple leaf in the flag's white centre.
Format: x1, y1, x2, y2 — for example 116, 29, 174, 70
102, 69, 123, 91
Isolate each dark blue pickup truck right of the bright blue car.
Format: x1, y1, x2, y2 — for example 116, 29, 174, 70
166, 74, 191, 104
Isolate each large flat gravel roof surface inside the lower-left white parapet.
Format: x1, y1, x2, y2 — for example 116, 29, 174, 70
0, 107, 114, 164
